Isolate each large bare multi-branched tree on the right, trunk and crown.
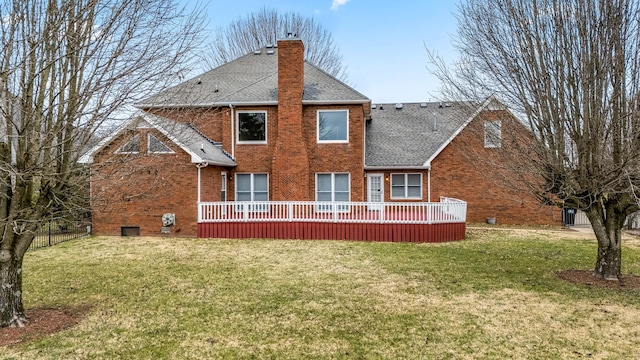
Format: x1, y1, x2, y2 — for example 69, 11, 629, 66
430, 0, 640, 280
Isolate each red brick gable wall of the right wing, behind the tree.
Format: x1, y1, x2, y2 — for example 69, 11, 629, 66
430, 111, 562, 225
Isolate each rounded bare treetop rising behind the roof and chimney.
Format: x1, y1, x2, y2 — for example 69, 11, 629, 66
203, 8, 347, 81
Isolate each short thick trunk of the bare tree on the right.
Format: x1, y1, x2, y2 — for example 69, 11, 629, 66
590, 213, 622, 280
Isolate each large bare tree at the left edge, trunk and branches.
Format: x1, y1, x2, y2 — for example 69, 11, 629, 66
0, 0, 202, 326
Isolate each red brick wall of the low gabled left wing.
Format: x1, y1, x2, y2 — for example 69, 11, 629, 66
91, 129, 221, 237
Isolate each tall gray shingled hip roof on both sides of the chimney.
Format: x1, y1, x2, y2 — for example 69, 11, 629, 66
136, 47, 369, 108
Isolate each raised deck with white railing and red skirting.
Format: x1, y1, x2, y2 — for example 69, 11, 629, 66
198, 198, 467, 242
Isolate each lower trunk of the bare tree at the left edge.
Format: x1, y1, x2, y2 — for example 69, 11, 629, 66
0, 250, 27, 327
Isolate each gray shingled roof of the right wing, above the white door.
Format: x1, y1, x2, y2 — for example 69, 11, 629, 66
365, 103, 480, 168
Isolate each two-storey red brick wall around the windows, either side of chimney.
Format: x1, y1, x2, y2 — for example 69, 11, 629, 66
144, 105, 366, 201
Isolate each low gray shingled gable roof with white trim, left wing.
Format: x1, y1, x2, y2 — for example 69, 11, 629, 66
79, 112, 236, 167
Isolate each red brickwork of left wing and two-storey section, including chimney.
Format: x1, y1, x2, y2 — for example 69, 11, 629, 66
92, 39, 369, 236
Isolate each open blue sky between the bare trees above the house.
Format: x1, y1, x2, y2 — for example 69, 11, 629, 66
200, 0, 458, 103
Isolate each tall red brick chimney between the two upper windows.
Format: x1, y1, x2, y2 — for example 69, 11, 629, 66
271, 38, 315, 201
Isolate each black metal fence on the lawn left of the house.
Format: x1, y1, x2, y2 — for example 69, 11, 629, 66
29, 218, 91, 250
